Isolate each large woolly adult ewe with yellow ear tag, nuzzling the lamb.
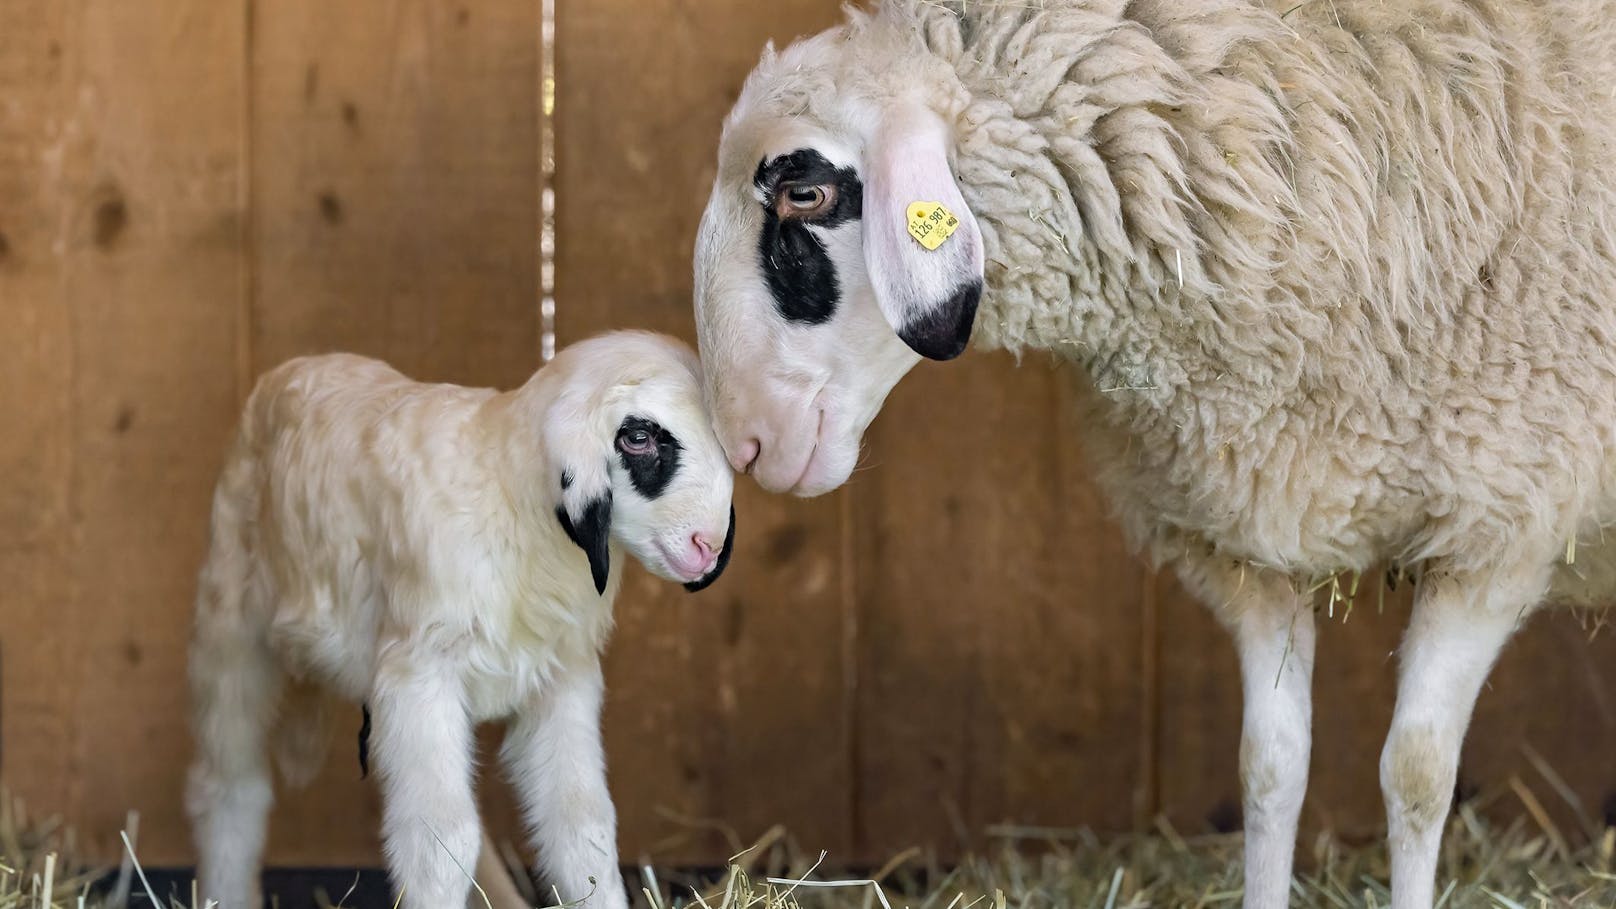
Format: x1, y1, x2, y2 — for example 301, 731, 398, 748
695, 0, 1616, 909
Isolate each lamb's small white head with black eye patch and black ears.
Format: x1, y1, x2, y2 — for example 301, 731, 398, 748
545, 332, 735, 594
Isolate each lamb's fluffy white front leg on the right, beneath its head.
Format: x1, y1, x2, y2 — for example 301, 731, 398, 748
503, 663, 629, 909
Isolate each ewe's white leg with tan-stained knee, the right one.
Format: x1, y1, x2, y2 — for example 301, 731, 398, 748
1380, 562, 1547, 909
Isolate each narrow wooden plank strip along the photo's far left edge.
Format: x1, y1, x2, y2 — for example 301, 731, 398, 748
0, 0, 74, 810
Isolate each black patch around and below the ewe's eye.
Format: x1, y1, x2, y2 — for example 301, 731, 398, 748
751, 149, 865, 325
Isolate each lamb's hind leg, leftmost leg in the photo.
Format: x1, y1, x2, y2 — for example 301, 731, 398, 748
186, 615, 281, 909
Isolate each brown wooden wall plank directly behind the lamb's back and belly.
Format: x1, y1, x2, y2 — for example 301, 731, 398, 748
250, 0, 540, 865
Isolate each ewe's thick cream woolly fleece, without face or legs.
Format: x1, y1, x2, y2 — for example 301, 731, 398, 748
748, 0, 1616, 591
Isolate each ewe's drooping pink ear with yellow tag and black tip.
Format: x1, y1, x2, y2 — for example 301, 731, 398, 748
863, 108, 983, 359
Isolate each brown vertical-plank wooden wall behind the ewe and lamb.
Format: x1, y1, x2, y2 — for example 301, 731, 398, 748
0, 0, 1616, 865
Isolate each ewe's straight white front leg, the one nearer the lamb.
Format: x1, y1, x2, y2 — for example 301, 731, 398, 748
1185, 563, 1314, 909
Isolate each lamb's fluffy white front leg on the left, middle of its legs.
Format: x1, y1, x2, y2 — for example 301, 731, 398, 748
370, 650, 482, 909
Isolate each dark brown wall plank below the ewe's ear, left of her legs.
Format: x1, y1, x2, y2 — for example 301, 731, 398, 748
852, 356, 1151, 860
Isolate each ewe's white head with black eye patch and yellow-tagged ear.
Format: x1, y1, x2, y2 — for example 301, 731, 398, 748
695, 19, 983, 495
